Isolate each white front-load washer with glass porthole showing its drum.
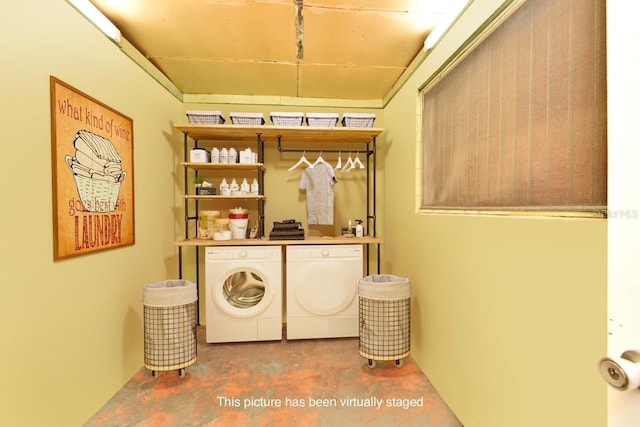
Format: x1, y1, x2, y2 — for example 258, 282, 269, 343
205, 246, 283, 343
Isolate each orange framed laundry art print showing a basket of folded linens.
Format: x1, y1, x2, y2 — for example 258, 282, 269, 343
50, 76, 135, 260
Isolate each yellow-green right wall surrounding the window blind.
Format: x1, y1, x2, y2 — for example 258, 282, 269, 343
383, 0, 607, 427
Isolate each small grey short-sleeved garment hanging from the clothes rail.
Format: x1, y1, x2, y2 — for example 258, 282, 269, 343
300, 163, 338, 225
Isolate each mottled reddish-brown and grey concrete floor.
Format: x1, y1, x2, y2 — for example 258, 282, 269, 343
86, 327, 461, 427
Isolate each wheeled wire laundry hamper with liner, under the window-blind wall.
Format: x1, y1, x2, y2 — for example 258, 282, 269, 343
358, 274, 411, 368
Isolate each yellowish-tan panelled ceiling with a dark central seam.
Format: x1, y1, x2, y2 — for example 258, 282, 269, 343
92, 0, 452, 100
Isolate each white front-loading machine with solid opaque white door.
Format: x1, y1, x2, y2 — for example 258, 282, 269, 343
286, 245, 363, 339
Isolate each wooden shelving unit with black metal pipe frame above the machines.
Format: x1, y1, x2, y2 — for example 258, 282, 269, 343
173, 124, 384, 322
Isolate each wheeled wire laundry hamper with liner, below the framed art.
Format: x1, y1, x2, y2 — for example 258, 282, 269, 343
143, 280, 198, 378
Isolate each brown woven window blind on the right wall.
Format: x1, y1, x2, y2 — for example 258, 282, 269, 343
422, 0, 607, 211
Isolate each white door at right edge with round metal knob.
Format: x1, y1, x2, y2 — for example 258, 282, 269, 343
607, 0, 640, 427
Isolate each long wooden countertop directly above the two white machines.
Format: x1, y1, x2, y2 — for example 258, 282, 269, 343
176, 236, 383, 246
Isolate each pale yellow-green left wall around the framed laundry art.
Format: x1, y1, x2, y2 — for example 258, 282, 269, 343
0, 0, 182, 426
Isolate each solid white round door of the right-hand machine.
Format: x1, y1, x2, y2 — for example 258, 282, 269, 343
294, 260, 358, 316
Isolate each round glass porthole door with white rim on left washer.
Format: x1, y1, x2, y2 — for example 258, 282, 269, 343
212, 266, 274, 318
